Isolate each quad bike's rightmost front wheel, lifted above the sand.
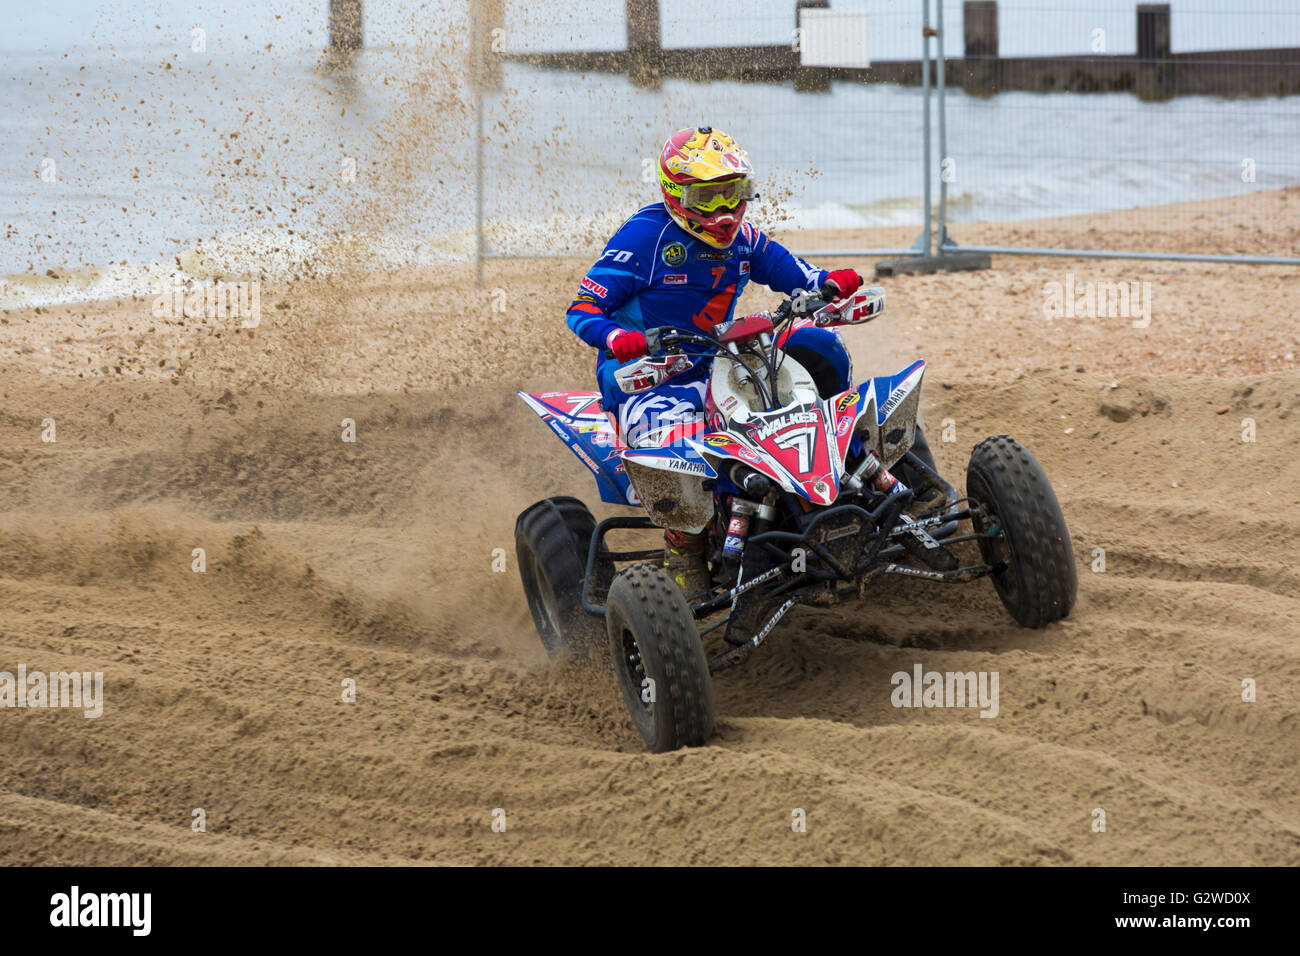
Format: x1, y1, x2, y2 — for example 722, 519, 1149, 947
966, 434, 1079, 627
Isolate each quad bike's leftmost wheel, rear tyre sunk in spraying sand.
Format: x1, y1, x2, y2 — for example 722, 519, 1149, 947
515, 497, 614, 659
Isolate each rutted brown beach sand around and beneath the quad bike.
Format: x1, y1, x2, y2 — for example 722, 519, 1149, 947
0, 190, 1300, 865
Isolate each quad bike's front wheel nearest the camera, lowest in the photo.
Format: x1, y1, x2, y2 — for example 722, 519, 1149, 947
605, 564, 714, 753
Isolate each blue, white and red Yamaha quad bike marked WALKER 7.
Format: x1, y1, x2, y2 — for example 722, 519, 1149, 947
515, 289, 1078, 752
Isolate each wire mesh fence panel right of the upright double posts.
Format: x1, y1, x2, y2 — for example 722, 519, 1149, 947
940, 0, 1300, 264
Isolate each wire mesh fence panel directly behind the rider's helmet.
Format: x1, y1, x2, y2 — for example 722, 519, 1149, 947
481, 0, 926, 265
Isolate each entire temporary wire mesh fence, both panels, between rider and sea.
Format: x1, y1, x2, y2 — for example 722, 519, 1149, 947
475, 0, 1300, 273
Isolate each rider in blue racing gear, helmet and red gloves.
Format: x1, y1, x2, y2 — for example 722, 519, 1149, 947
567, 126, 862, 604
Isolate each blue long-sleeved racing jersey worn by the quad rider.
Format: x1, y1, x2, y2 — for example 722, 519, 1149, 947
567, 203, 827, 408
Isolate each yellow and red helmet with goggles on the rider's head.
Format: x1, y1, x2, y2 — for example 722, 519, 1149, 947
659, 126, 758, 248
